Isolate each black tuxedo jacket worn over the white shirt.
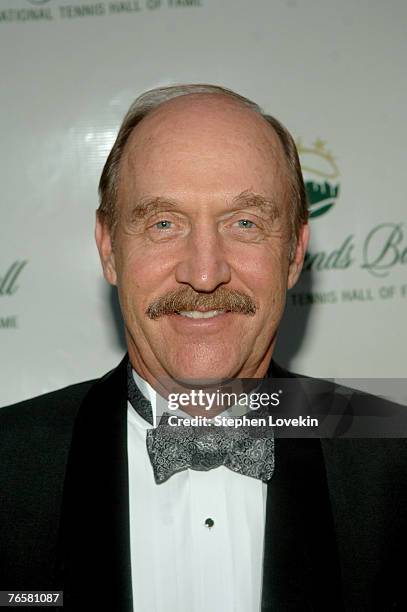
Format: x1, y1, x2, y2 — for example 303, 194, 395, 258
0, 357, 407, 612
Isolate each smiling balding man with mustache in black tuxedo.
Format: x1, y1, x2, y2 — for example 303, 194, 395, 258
0, 85, 407, 612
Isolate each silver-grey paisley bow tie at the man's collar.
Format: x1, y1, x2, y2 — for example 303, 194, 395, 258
128, 362, 274, 484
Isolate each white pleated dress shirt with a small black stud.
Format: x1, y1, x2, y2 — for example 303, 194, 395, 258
128, 372, 267, 612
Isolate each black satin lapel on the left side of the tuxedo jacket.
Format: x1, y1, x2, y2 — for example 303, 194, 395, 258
57, 355, 132, 612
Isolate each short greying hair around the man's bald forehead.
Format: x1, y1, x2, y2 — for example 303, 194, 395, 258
98, 84, 308, 258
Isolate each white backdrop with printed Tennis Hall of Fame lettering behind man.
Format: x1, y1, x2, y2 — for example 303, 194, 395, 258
0, 0, 407, 405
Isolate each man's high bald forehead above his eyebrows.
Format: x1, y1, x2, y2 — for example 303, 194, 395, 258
119, 94, 288, 203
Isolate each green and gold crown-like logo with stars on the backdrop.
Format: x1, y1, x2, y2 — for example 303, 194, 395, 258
297, 138, 339, 219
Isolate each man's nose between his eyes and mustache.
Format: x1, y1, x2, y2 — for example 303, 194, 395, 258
175, 225, 231, 292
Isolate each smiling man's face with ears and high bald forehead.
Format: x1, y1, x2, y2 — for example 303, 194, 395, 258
96, 95, 307, 382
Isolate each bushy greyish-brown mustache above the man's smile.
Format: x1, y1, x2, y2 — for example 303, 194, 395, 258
146, 286, 256, 319
